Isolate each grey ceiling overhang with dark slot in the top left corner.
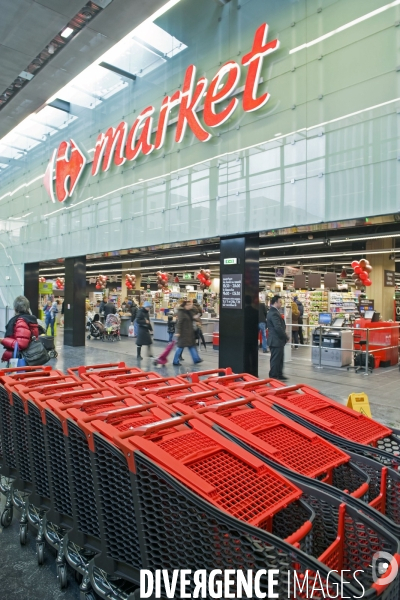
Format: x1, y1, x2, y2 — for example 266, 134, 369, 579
0, 0, 169, 139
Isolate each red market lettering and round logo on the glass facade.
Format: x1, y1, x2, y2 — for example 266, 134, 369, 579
44, 23, 279, 202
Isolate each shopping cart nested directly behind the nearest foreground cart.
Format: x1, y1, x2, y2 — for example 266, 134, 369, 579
72, 395, 173, 600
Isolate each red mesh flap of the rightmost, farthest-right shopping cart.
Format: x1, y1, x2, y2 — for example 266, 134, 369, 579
253, 384, 392, 446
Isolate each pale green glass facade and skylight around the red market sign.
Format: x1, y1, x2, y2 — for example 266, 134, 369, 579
0, 0, 400, 356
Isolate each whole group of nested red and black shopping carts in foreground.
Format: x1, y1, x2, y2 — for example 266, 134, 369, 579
0, 363, 400, 600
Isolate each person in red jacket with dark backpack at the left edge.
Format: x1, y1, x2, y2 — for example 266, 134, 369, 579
0, 296, 39, 362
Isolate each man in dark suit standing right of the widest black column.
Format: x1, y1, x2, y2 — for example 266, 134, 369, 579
267, 296, 288, 381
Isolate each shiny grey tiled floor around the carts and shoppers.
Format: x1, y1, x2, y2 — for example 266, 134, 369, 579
0, 332, 400, 600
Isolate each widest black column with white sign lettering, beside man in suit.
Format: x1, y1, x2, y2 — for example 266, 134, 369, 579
219, 234, 259, 376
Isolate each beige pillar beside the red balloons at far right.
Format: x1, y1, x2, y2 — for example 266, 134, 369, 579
366, 238, 395, 321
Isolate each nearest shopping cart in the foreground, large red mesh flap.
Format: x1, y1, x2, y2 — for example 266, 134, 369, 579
106, 415, 400, 598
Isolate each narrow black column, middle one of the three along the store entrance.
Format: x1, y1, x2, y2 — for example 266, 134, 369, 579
64, 256, 86, 346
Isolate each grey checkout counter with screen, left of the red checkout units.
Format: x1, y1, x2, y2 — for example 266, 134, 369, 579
311, 313, 353, 367
